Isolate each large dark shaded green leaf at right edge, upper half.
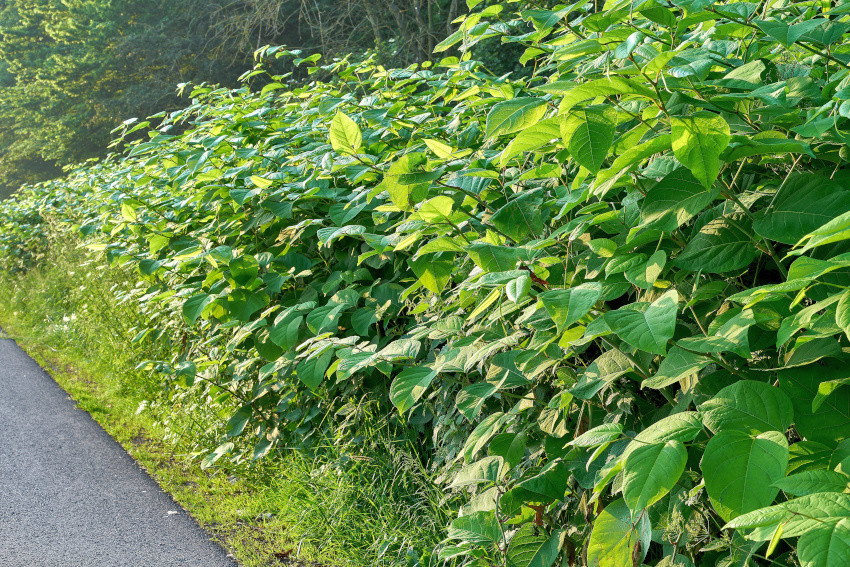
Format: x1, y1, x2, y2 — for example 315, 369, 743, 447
753, 173, 850, 244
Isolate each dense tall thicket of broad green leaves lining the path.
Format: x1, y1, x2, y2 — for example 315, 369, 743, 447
0, 0, 850, 567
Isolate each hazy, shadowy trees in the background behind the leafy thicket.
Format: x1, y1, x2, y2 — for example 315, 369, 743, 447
0, 0, 467, 195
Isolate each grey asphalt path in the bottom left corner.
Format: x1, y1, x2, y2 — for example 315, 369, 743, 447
0, 330, 236, 567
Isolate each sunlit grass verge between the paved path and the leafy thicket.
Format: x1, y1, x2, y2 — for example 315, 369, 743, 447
0, 233, 449, 567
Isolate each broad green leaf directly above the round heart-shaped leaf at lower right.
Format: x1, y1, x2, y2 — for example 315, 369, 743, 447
699, 380, 794, 434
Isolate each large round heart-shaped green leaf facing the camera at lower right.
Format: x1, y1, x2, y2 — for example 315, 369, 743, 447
700, 430, 788, 521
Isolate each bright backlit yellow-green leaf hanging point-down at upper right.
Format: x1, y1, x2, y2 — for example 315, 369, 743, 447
671, 112, 732, 188
